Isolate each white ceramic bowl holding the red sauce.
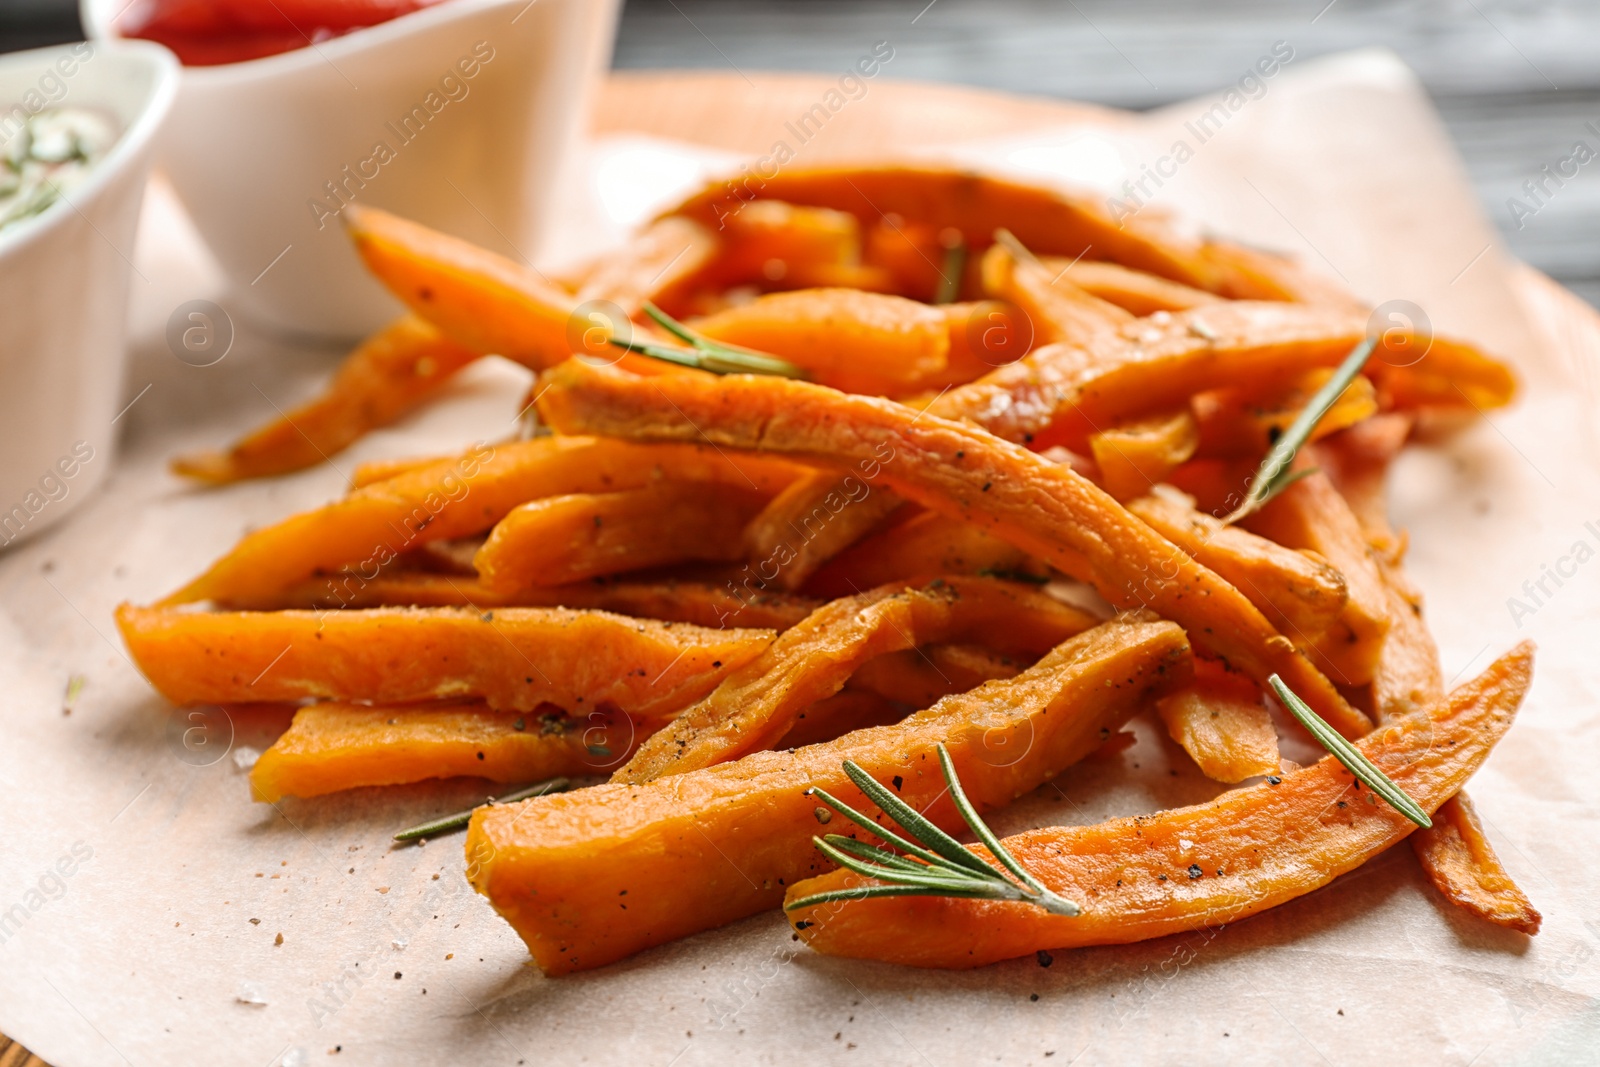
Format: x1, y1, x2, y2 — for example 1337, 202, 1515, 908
80, 0, 618, 338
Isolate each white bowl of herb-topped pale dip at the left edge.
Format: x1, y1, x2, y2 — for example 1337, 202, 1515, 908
0, 42, 178, 545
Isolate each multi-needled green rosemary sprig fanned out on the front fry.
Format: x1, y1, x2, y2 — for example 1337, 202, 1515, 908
784, 744, 1082, 915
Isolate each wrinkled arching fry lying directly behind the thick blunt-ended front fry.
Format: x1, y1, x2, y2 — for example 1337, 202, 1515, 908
613, 577, 1096, 784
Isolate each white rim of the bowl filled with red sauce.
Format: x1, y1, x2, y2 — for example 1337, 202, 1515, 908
78, 0, 549, 86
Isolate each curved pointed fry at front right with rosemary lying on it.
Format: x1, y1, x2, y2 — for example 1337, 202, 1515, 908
787, 645, 1533, 968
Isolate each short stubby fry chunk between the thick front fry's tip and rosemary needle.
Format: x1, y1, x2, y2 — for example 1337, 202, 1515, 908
1155, 659, 1278, 784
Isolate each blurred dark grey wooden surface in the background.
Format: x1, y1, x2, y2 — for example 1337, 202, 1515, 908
0, 0, 1600, 306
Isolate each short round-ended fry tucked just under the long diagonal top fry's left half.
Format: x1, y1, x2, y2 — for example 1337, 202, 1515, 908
472, 482, 766, 593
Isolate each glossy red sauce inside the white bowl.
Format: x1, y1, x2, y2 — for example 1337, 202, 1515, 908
117, 0, 442, 67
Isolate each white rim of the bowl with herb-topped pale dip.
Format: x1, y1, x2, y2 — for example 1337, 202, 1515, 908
0, 40, 179, 266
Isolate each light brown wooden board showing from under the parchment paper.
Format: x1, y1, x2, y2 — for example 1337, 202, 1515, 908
0, 72, 1600, 1067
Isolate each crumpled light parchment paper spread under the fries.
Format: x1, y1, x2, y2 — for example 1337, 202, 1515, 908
0, 53, 1600, 1067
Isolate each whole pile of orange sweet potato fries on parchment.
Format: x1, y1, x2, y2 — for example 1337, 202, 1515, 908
118, 166, 1539, 974
